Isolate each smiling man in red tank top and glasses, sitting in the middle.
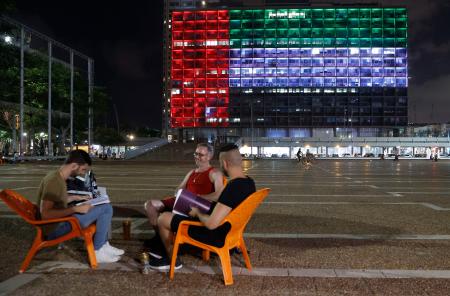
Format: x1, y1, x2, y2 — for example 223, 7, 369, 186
144, 143, 223, 238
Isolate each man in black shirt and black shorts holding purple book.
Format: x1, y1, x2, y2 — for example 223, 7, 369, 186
150, 144, 256, 270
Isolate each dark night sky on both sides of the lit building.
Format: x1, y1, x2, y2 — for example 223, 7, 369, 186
6, 0, 450, 129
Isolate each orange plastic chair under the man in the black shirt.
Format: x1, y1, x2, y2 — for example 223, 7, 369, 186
169, 188, 270, 285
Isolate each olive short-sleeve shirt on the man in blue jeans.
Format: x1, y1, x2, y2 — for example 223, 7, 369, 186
38, 170, 67, 235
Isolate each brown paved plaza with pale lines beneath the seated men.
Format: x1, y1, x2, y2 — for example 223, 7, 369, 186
0, 159, 450, 295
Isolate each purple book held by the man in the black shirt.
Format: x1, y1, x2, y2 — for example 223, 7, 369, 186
172, 189, 212, 217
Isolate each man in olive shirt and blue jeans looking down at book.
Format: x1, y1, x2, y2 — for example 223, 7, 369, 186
38, 150, 124, 263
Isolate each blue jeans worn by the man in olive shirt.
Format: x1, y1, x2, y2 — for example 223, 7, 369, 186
47, 204, 113, 250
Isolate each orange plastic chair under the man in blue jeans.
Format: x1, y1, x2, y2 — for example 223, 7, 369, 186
0, 189, 97, 273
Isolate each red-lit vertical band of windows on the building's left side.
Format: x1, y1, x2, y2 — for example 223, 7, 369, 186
170, 10, 229, 127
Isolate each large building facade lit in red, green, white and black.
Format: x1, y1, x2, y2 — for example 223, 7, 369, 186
163, 0, 408, 139
